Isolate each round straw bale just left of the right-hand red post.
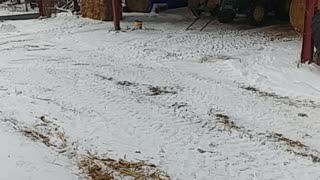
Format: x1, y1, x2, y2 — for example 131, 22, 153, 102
290, 0, 320, 33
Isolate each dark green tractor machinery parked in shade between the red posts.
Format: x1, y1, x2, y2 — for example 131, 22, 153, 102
189, 0, 291, 26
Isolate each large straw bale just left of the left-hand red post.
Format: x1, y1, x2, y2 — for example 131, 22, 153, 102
80, 0, 112, 21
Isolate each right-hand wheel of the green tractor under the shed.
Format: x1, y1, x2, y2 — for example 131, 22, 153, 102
247, 2, 267, 26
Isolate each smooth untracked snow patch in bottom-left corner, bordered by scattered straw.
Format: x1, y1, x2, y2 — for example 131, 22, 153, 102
0, 127, 74, 180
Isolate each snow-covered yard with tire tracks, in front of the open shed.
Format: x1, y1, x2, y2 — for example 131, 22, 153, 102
0, 8, 320, 180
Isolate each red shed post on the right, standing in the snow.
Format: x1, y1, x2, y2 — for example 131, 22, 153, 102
301, 0, 318, 63
